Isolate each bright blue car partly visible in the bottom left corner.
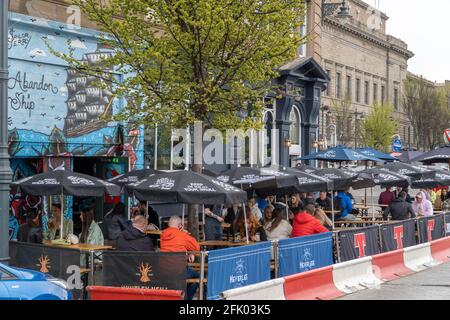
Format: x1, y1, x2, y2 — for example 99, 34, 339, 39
0, 263, 72, 300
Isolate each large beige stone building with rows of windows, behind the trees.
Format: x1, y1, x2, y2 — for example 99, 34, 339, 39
321, 0, 413, 146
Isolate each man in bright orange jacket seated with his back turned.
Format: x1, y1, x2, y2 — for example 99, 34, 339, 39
160, 216, 200, 300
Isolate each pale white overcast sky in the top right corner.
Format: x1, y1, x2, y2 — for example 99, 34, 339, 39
365, 0, 450, 82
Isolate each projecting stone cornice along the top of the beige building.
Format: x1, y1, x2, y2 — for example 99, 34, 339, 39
324, 17, 414, 59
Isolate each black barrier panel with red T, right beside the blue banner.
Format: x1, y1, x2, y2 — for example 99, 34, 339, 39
337, 226, 380, 262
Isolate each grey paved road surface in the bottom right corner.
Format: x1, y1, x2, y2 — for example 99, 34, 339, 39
338, 263, 450, 300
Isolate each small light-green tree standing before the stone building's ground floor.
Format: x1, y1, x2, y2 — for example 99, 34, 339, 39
361, 105, 397, 152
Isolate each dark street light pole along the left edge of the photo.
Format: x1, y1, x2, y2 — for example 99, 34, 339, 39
0, 0, 12, 263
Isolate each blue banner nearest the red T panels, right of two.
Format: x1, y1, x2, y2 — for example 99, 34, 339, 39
278, 232, 333, 277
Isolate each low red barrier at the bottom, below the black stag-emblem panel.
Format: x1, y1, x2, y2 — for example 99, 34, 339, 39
86, 286, 183, 300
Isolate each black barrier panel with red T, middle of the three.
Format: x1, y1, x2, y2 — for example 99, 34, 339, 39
380, 219, 417, 252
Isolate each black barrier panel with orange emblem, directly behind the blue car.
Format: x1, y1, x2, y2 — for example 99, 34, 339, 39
9, 241, 81, 299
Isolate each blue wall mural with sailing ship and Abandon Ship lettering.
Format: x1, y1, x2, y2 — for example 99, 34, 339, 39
8, 13, 144, 169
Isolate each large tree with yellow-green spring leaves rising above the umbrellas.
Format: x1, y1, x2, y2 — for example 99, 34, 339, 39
52, 0, 307, 235
